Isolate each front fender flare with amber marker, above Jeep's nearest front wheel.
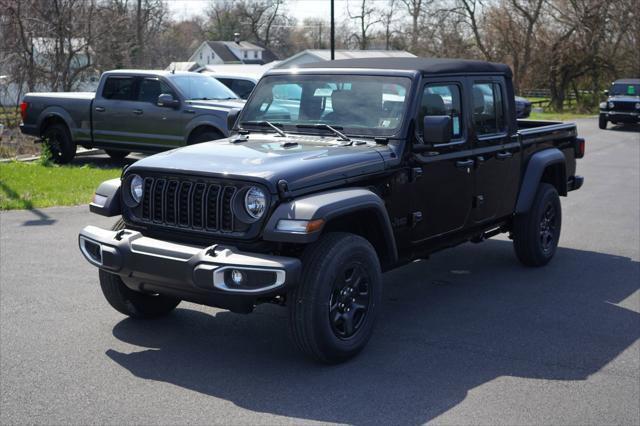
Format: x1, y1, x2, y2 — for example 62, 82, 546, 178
263, 188, 398, 263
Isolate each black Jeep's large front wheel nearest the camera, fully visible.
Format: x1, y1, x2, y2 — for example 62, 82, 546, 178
287, 232, 382, 364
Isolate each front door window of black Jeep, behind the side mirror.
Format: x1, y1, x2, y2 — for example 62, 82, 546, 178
418, 84, 463, 139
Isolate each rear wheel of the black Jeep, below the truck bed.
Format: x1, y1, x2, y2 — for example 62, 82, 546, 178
513, 183, 562, 266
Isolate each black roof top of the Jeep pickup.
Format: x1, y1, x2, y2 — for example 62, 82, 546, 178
300, 58, 511, 77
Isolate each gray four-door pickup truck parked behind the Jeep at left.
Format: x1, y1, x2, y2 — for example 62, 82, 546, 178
20, 70, 244, 163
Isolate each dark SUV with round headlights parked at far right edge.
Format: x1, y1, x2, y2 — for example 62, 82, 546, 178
598, 78, 640, 129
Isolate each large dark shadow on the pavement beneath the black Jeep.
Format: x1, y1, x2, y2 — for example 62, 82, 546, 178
106, 241, 640, 424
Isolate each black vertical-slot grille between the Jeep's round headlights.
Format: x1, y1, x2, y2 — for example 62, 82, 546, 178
138, 177, 238, 232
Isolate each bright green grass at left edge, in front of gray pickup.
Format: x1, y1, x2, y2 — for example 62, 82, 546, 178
0, 162, 121, 210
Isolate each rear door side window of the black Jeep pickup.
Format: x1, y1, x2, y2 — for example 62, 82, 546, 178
473, 83, 506, 136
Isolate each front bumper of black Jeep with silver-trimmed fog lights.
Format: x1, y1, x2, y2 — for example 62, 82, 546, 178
78, 226, 301, 310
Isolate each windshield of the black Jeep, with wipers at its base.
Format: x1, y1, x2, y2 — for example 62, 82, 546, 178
241, 74, 411, 136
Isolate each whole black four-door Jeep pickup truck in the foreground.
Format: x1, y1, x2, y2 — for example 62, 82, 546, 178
79, 58, 585, 363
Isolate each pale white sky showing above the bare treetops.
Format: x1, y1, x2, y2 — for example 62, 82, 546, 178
166, 0, 356, 23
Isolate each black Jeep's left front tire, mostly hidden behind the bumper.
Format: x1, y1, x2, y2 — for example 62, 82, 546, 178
99, 219, 180, 318
